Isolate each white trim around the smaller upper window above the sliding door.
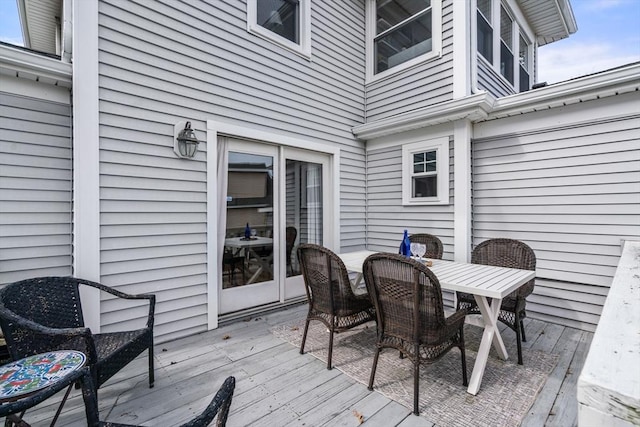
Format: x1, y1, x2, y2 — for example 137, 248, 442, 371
247, 0, 311, 59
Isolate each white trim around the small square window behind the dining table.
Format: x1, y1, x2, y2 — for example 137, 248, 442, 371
402, 136, 449, 206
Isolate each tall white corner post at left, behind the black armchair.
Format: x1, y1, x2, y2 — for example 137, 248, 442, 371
72, 0, 100, 333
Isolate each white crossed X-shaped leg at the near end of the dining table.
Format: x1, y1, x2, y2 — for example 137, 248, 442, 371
467, 295, 509, 395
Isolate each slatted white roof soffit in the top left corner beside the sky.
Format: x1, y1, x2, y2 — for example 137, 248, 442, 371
17, 0, 62, 55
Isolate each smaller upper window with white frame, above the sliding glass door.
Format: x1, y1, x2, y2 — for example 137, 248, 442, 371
247, 0, 311, 57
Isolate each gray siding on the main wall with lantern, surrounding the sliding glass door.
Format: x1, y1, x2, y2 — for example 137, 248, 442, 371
99, 0, 365, 341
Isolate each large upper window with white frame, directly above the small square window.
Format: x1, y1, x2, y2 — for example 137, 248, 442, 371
367, 0, 442, 82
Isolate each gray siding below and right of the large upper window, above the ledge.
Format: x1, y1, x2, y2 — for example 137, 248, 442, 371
366, 0, 453, 122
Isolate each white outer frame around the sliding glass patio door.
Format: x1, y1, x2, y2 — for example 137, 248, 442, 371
207, 120, 340, 329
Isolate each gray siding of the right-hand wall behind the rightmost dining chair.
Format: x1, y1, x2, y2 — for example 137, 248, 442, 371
473, 110, 640, 330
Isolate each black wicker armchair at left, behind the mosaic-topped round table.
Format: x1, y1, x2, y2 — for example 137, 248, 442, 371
0, 277, 155, 394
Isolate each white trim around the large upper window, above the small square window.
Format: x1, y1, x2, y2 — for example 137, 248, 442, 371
365, 0, 442, 84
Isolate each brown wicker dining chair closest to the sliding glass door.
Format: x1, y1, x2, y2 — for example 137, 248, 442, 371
298, 243, 375, 369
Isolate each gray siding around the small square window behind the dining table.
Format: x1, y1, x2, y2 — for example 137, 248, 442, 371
366, 141, 454, 305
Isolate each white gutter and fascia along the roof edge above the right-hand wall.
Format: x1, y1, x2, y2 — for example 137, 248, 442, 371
487, 64, 640, 120
